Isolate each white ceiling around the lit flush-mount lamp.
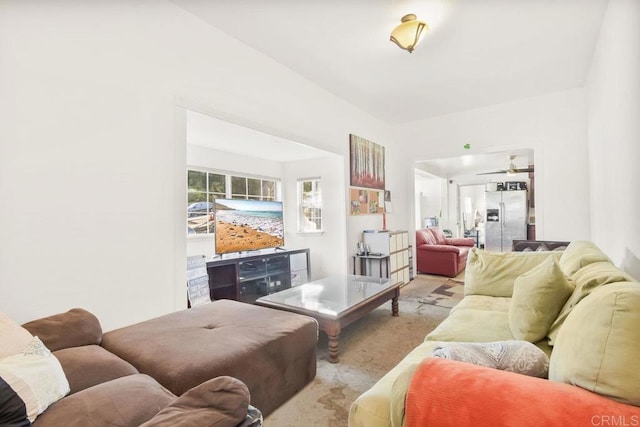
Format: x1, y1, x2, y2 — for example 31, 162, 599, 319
173, 0, 607, 124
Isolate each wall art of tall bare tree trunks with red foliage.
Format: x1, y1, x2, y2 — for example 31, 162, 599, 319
349, 134, 384, 190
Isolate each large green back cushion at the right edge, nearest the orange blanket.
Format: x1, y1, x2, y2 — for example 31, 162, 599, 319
549, 283, 640, 406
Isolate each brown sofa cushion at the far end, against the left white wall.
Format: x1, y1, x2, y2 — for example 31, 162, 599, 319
22, 308, 102, 351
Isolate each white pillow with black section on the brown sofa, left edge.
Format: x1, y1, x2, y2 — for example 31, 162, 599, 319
0, 337, 69, 425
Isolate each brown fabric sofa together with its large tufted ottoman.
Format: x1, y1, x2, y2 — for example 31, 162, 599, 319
23, 300, 318, 427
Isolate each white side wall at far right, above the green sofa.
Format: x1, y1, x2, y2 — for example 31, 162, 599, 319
587, 0, 640, 279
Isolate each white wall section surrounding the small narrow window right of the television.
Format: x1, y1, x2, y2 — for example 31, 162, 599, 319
283, 154, 344, 280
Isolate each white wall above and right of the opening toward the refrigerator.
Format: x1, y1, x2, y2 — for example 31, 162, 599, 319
397, 89, 590, 246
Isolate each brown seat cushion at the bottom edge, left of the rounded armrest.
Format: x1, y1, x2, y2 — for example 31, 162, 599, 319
33, 374, 176, 427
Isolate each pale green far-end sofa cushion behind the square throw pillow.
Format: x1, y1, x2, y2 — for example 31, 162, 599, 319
464, 248, 562, 297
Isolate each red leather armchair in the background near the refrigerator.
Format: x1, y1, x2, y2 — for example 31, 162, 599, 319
416, 227, 475, 277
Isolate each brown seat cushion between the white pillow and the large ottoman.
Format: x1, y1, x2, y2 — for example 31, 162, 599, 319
53, 345, 138, 394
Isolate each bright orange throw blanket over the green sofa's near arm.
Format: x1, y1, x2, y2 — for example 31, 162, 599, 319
405, 358, 640, 427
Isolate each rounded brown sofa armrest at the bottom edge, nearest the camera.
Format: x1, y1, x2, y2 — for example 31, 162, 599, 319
141, 377, 250, 427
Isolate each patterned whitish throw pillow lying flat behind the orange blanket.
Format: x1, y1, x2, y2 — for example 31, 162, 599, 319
433, 340, 549, 378
